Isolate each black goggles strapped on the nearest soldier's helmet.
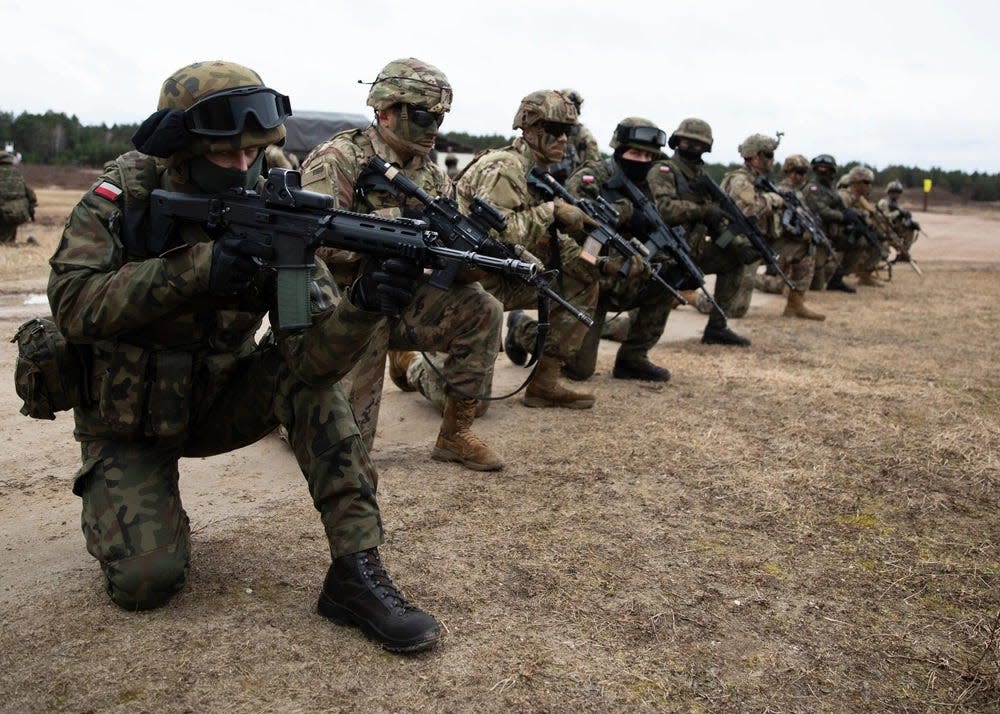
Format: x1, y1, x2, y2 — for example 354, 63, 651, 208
184, 87, 292, 136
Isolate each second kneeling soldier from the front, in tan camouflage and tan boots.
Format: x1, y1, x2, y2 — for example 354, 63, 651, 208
294, 57, 503, 471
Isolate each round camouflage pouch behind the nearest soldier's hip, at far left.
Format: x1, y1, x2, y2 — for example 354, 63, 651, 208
11, 317, 89, 419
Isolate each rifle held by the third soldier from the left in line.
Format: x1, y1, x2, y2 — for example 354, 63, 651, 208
528, 166, 687, 305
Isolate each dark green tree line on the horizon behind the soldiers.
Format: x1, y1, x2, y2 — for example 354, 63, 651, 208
0, 111, 1000, 201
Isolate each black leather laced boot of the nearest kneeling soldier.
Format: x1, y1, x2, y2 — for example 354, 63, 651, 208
316, 548, 441, 652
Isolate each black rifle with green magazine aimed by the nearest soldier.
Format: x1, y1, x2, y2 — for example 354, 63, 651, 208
151, 168, 538, 330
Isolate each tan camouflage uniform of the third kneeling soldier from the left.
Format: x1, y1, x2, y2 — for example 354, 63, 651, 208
456, 137, 601, 362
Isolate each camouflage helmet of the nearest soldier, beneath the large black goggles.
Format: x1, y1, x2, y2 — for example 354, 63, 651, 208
156, 60, 291, 156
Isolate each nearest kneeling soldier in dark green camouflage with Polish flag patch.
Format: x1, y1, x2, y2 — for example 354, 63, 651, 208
48, 62, 440, 651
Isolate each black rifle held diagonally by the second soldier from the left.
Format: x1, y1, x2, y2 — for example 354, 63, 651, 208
368, 156, 594, 327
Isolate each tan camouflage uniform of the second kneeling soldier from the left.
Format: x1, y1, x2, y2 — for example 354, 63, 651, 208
302, 126, 502, 445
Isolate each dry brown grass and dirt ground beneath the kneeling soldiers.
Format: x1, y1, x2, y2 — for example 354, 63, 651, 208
0, 181, 1000, 712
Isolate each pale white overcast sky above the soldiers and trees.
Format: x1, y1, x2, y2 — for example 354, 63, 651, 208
0, 0, 1000, 173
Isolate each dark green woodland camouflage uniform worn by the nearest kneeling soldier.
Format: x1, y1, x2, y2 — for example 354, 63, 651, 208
48, 152, 383, 609
